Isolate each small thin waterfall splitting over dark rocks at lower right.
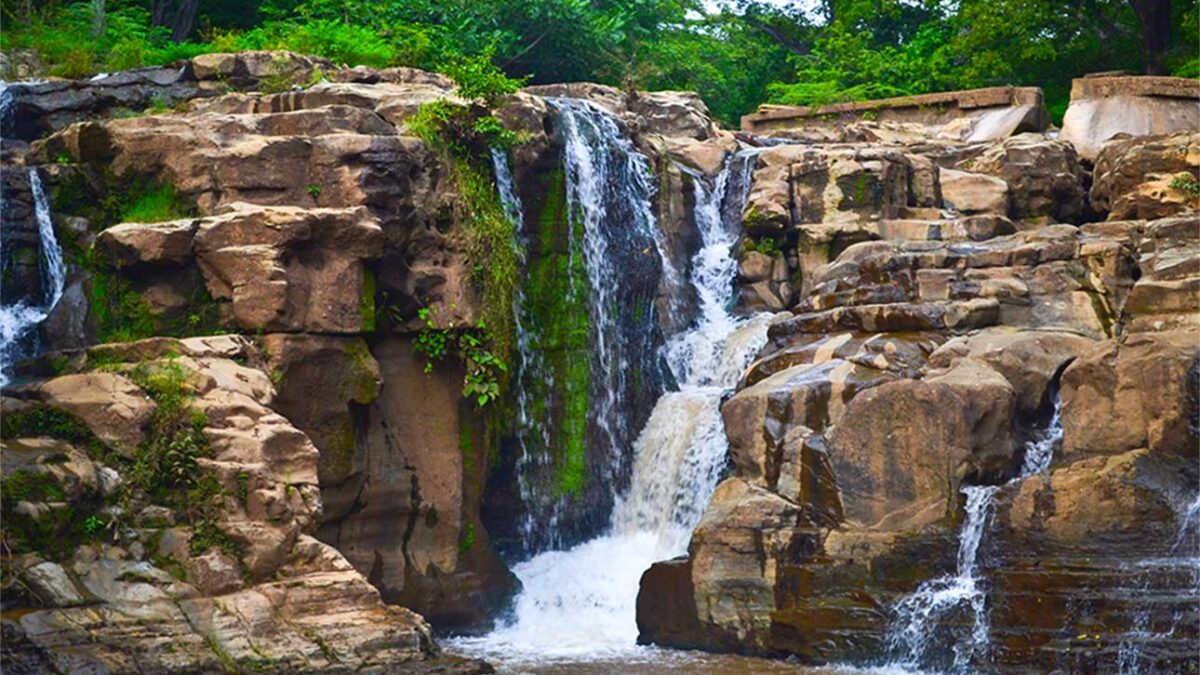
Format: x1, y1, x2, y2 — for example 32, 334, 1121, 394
887, 399, 1062, 673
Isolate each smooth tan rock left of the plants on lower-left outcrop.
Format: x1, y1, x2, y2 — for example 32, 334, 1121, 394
37, 372, 155, 456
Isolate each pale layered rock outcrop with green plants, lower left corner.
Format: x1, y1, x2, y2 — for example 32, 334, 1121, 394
0, 336, 490, 673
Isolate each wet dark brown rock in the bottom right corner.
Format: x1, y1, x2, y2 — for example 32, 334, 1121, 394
979, 449, 1200, 670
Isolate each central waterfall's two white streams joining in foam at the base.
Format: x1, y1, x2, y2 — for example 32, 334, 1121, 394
454, 139, 770, 663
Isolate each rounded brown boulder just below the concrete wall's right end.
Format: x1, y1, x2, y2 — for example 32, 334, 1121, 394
964, 133, 1086, 222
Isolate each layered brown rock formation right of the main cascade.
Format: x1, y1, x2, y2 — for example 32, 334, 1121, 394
638, 89, 1200, 671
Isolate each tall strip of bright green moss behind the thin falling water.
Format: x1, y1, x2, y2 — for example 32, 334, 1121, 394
526, 169, 592, 495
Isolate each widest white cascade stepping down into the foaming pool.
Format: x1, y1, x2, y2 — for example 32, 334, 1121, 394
451, 144, 770, 667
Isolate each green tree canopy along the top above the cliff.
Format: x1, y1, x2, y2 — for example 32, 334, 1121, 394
0, 0, 1200, 125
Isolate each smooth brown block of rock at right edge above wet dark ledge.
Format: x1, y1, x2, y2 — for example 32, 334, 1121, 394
1062, 330, 1200, 459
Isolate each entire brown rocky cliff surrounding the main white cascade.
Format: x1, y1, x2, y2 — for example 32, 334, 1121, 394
0, 53, 1200, 673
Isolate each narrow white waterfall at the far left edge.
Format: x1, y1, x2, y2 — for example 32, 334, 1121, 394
0, 168, 66, 386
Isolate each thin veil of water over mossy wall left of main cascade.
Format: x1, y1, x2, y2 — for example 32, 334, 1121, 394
497, 98, 678, 555
